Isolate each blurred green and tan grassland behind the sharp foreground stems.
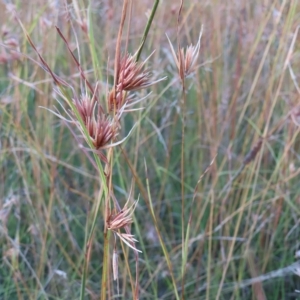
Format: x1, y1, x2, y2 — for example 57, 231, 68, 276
0, 0, 300, 300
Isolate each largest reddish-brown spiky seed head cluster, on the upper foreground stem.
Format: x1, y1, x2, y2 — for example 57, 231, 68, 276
69, 54, 164, 160
